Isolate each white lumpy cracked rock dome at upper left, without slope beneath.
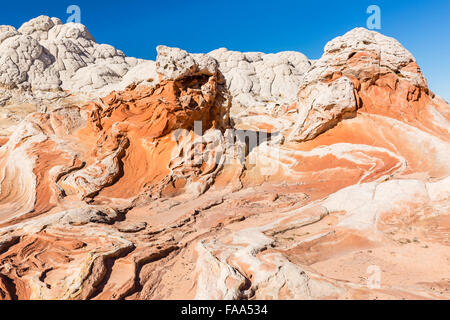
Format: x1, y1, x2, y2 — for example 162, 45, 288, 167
0, 16, 157, 94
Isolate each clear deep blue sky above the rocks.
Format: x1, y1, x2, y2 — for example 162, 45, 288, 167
0, 0, 450, 101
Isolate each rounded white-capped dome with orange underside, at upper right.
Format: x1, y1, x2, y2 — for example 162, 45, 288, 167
284, 28, 432, 141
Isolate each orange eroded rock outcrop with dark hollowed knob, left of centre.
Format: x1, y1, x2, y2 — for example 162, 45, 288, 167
2, 48, 229, 221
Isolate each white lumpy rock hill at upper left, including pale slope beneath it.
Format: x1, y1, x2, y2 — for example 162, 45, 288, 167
0, 16, 157, 136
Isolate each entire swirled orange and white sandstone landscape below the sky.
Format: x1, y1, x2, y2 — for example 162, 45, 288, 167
0, 17, 450, 299
